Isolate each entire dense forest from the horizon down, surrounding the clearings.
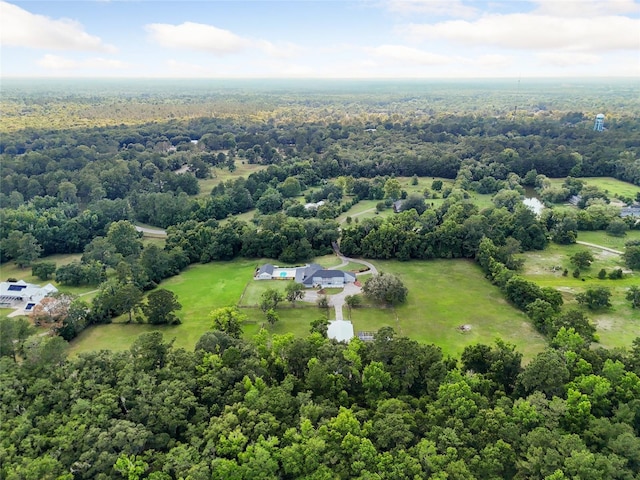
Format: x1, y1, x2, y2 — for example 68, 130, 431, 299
0, 82, 640, 480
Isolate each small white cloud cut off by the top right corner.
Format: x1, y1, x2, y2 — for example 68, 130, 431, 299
534, 0, 640, 17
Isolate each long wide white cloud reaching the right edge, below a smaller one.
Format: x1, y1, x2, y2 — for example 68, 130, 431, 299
407, 13, 640, 52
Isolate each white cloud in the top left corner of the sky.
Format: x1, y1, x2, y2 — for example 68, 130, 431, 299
0, 1, 116, 53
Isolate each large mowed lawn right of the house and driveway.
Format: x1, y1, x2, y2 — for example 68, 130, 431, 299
370, 260, 546, 360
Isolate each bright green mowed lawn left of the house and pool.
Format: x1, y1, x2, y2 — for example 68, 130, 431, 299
71, 259, 256, 354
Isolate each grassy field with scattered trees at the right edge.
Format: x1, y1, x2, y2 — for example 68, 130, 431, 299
522, 244, 640, 348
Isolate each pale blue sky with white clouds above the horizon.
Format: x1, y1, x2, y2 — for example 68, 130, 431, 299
0, 0, 640, 78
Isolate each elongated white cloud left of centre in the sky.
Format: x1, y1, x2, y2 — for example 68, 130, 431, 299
145, 22, 299, 57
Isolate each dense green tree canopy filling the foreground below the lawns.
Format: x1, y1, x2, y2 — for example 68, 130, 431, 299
0, 329, 640, 480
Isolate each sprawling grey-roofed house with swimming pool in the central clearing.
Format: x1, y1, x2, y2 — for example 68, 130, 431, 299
254, 263, 356, 288
